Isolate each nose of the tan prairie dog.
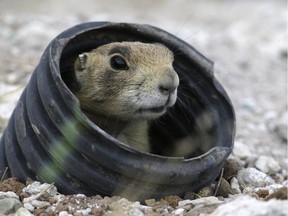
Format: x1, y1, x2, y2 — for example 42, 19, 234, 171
159, 69, 179, 94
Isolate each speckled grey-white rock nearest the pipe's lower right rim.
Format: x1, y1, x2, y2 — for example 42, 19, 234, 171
237, 167, 274, 187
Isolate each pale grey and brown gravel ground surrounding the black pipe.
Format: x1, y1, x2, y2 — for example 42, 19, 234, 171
0, 0, 288, 215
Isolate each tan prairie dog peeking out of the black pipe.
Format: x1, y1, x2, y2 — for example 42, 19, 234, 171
74, 42, 179, 152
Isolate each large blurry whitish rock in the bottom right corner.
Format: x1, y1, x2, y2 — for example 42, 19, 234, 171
209, 195, 288, 216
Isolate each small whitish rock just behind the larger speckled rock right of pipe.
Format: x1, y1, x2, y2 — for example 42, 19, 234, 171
255, 156, 281, 174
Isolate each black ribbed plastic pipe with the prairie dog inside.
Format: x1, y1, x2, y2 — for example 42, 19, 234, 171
0, 22, 235, 200
